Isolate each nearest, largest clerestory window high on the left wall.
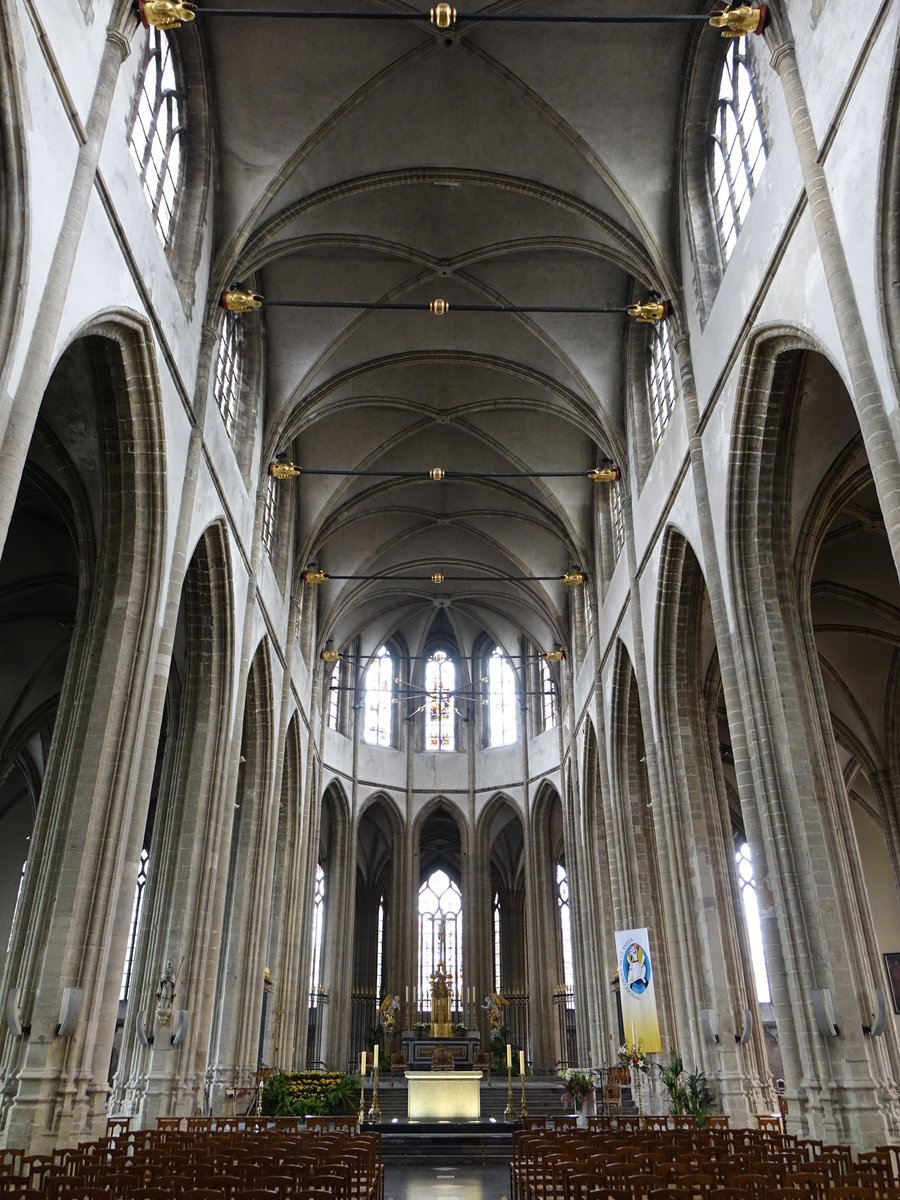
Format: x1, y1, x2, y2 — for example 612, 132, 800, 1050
128, 29, 184, 246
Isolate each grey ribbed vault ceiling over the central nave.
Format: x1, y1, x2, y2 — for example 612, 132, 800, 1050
198, 0, 696, 653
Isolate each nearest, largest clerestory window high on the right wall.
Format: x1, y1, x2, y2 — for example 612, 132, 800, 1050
713, 37, 766, 263
